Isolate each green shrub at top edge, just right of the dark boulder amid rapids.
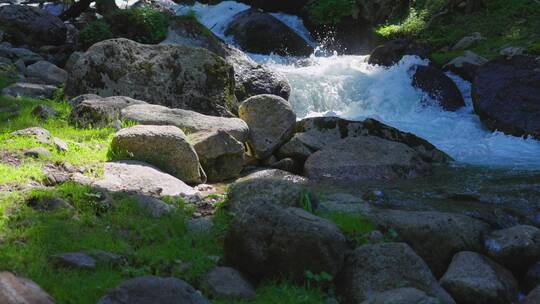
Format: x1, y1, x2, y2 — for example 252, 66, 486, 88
309, 0, 358, 25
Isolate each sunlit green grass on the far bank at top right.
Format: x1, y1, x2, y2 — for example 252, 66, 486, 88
376, 0, 540, 64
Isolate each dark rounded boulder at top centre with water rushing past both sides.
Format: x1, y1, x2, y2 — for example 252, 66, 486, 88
225, 9, 313, 56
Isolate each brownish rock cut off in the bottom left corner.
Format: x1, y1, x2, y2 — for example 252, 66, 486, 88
0, 271, 54, 304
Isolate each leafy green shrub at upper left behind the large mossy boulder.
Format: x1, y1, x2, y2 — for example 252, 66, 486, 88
105, 7, 169, 44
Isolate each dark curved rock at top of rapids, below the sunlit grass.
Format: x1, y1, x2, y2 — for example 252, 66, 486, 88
368, 40, 430, 67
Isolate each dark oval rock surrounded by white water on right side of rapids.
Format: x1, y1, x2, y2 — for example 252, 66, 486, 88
412, 65, 465, 111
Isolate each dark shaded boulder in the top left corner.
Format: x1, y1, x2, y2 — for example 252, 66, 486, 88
0, 5, 67, 47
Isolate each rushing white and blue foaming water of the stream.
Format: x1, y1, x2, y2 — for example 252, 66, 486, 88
178, 1, 540, 169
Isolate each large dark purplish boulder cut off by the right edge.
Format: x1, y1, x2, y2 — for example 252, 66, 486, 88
472, 56, 540, 139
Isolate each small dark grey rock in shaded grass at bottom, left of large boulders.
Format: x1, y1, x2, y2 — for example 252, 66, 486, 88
203, 267, 256, 300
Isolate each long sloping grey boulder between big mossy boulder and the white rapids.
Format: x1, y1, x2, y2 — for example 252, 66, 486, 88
161, 16, 291, 101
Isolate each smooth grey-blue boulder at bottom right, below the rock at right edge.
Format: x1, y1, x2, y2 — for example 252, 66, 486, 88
441, 251, 518, 304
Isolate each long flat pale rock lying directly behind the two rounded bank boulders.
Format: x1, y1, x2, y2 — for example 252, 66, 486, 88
122, 104, 249, 142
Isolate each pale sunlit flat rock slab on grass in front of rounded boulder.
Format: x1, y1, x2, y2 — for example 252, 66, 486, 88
93, 161, 200, 200
